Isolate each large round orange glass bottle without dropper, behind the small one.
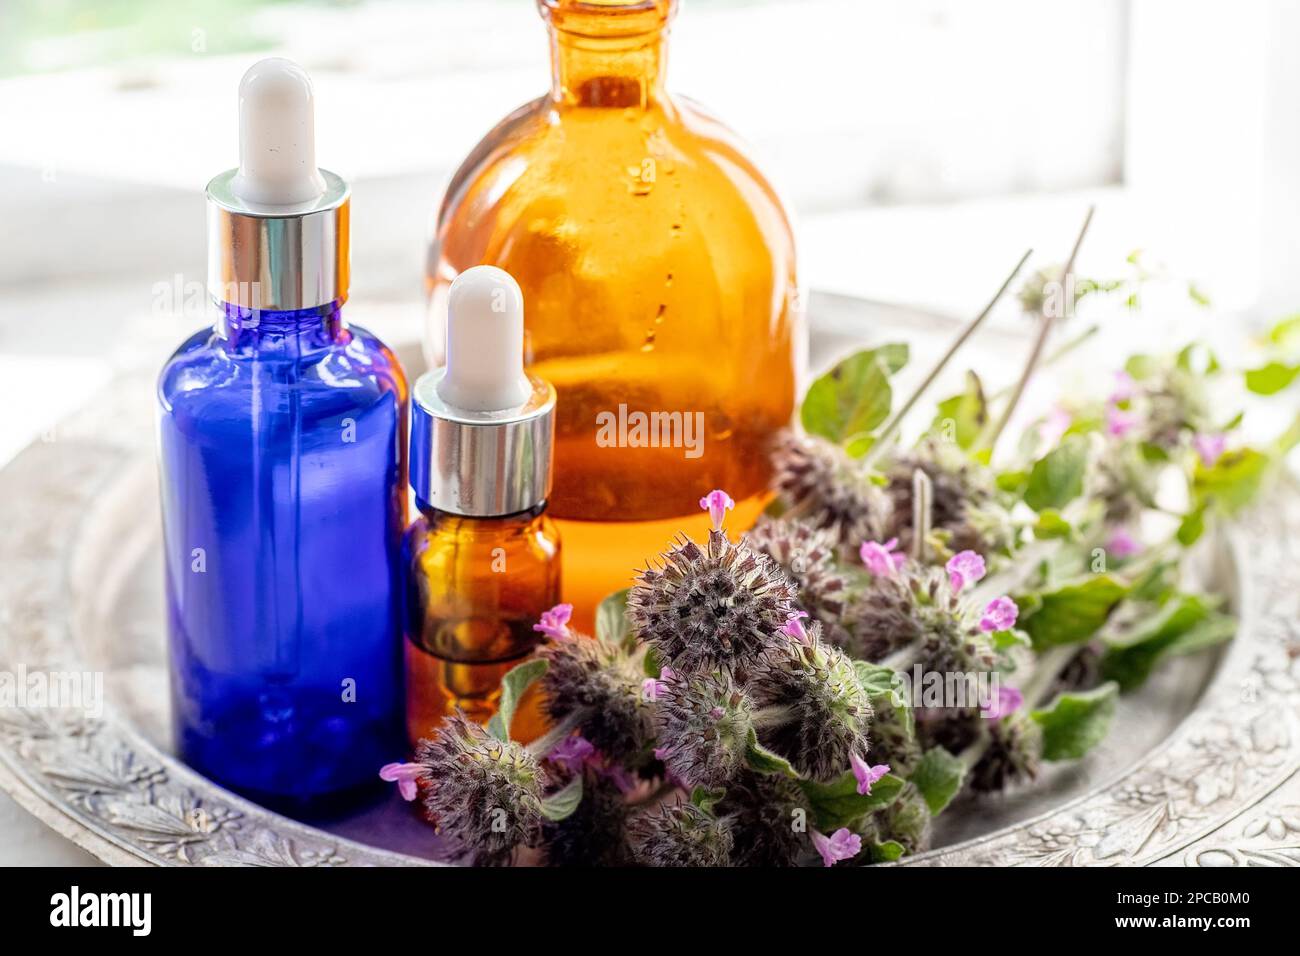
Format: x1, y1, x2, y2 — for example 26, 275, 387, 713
428, 0, 802, 622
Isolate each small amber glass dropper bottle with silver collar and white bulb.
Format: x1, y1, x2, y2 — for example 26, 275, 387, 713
404, 265, 560, 744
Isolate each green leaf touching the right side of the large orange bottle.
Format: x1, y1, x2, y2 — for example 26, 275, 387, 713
800, 345, 907, 444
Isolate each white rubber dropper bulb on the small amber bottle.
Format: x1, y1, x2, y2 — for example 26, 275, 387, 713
438, 265, 533, 411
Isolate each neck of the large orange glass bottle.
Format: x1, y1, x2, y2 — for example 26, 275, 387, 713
538, 0, 676, 109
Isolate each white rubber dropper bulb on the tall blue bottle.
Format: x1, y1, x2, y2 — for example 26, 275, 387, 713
230, 56, 325, 206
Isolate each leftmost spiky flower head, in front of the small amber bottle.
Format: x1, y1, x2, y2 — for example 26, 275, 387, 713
416, 711, 549, 866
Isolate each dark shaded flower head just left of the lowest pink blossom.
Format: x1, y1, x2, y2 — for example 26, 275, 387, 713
718, 773, 811, 866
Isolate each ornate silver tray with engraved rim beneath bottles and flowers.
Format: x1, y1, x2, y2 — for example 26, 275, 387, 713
0, 306, 1300, 866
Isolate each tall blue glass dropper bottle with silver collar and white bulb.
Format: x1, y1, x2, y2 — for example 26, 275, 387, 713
159, 59, 407, 816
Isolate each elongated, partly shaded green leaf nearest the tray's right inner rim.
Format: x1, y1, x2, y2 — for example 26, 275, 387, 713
1101, 594, 1236, 691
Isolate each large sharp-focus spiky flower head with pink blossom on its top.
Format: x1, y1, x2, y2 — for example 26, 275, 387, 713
626, 531, 794, 681
